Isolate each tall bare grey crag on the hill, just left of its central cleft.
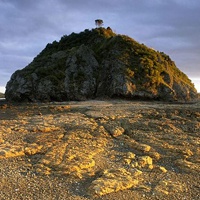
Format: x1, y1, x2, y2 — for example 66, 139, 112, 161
64, 45, 99, 100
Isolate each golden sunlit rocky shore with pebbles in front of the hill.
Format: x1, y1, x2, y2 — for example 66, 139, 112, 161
0, 100, 200, 200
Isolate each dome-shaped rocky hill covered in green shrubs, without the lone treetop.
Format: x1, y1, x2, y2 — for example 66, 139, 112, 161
5, 28, 197, 101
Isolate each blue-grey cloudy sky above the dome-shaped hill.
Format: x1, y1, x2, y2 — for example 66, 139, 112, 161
0, 0, 200, 92
